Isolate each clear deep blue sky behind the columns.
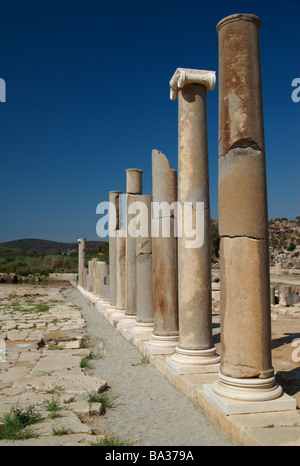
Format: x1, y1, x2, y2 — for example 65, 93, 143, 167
0, 0, 300, 242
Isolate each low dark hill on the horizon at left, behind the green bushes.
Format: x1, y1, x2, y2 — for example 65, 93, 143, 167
0, 238, 101, 254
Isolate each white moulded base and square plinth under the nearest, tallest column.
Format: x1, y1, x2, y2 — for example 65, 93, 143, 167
203, 372, 297, 415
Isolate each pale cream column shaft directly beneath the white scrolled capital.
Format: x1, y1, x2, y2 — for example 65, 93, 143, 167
178, 84, 213, 350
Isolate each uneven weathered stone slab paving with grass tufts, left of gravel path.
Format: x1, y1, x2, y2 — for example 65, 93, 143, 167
0, 284, 107, 446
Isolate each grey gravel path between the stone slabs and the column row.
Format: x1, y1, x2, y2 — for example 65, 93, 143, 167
64, 288, 232, 446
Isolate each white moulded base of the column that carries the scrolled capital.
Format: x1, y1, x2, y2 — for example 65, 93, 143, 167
166, 346, 220, 374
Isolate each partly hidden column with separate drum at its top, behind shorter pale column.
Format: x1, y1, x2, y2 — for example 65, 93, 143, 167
119, 168, 143, 327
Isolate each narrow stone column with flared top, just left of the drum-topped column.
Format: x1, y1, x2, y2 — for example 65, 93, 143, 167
109, 191, 122, 306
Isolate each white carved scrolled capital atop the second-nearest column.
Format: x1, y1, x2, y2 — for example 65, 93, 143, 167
170, 68, 216, 100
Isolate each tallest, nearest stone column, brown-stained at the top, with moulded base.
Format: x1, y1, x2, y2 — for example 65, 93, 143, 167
204, 14, 288, 412
